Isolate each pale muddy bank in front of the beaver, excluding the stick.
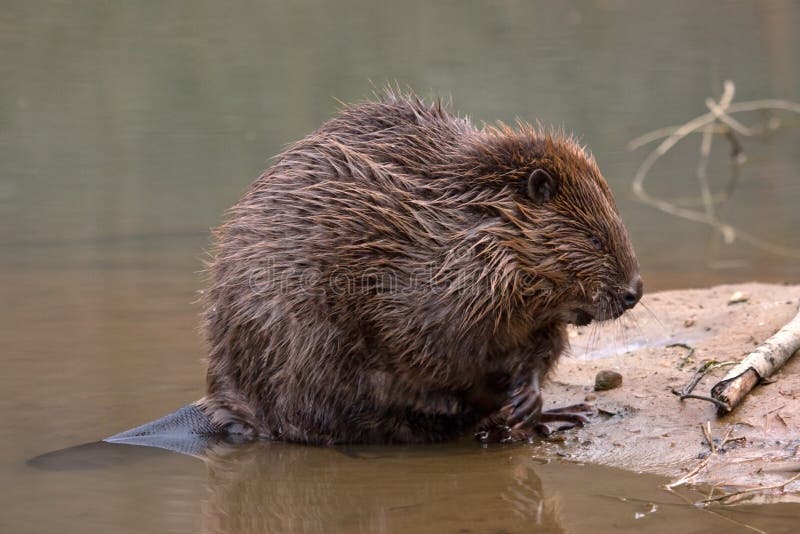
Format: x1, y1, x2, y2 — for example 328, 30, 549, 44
537, 283, 800, 501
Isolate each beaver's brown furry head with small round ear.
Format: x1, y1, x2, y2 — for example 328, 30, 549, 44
460, 125, 642, 325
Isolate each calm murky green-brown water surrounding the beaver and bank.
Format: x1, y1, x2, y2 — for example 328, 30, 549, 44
0, 0, 800, 532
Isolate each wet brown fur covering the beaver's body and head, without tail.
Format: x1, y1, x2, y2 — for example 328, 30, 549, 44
201, 91, 638, 443
